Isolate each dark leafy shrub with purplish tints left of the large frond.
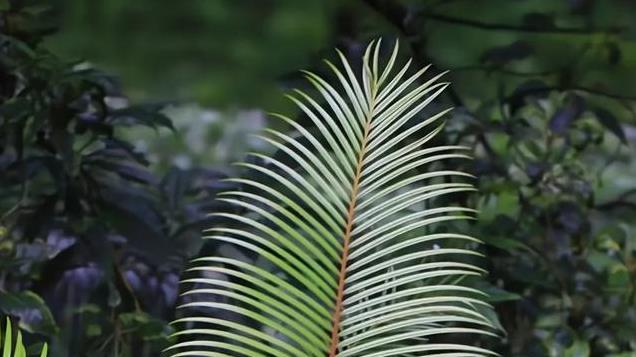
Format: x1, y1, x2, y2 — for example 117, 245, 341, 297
0, 1, 231, 356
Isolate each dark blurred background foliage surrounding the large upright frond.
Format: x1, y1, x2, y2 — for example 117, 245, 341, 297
0, 0, 636, 357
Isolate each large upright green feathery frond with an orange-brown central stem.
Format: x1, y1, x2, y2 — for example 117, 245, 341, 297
169, 41, 495, 357
